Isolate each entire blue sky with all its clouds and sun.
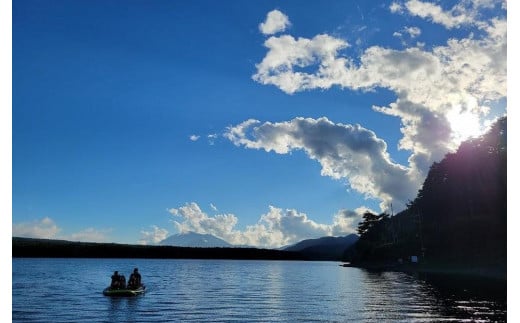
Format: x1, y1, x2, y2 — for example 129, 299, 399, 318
11, 0, 509, 248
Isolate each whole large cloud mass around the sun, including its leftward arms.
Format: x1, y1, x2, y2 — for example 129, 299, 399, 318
231, 0, 507, 213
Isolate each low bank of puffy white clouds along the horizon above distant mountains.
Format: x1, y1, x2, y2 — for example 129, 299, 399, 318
169, 202, 365, 248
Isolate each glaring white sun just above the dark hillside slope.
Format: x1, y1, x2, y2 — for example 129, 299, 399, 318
446, 109, 482, 143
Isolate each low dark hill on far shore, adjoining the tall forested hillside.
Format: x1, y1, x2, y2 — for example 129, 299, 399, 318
282, 234, 359, 260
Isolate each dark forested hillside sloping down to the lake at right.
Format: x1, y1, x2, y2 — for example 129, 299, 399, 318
345, 117, 507, 273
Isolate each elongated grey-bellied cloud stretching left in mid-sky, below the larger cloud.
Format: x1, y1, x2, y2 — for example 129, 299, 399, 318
225, 118, 419, 208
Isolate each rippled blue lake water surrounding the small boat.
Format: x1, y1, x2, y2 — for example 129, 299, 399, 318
12, 258, 506, 322
